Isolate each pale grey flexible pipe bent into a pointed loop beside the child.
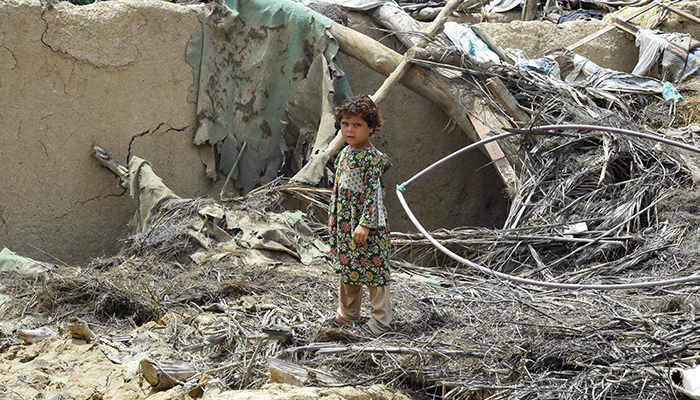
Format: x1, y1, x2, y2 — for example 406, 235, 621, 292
396, 125, 700, 290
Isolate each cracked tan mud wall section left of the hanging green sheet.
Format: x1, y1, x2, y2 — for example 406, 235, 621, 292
0, 0, 209, 263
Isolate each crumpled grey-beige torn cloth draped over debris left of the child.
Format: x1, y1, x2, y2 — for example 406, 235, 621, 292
126, 156, 330, 270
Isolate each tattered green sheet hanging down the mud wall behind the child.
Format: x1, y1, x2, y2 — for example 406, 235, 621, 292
187, 0, 347, 192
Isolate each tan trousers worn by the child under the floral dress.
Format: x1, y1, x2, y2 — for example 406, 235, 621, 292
336, 280, 392, 335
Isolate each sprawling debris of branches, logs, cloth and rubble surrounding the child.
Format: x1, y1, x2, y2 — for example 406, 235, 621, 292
0, 1, 700, 399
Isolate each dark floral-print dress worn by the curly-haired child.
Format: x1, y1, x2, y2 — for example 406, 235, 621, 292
328, 146, 390, 286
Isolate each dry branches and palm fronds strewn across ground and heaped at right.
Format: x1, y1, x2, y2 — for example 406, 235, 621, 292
0, 3, 700, 399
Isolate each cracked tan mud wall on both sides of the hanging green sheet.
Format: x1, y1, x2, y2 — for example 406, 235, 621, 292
0, 0, 506, 263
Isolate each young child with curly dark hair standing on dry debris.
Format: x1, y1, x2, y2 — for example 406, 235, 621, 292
328, 96, 392, 336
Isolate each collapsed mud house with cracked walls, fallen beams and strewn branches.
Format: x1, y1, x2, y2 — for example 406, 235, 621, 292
0, 2, 698, 398
